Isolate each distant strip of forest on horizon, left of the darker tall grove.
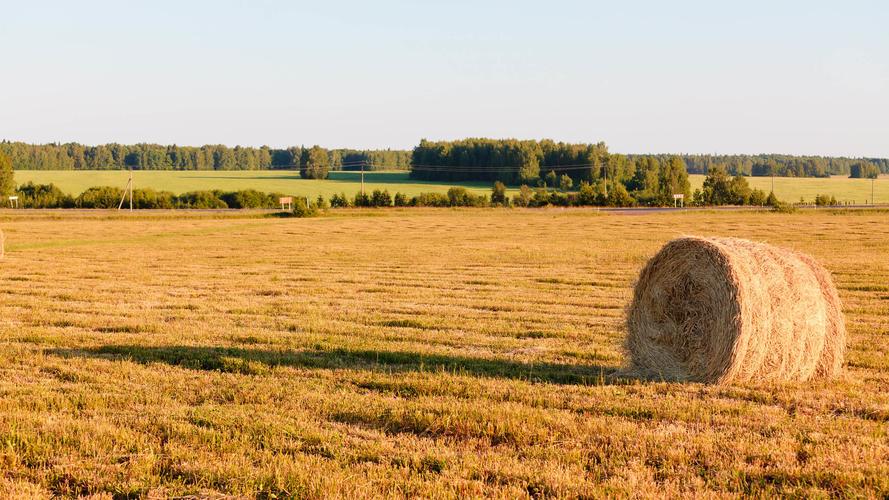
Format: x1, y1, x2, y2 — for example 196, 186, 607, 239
0, 141, 410, 170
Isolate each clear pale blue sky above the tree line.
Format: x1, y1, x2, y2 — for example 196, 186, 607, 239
0, 0, 889, 157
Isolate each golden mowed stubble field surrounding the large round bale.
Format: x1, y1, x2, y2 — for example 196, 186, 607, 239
0, 209, 889, 498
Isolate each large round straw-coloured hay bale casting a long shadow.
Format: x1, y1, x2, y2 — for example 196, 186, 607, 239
625, 237, 846, 383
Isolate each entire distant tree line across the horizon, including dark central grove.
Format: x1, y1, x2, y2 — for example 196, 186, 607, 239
0, 139, 889, 185
